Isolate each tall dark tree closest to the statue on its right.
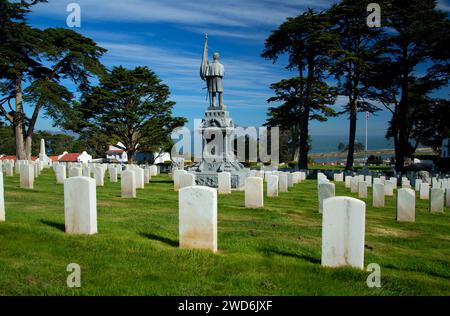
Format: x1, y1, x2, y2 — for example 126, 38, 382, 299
262, 9, 337, 169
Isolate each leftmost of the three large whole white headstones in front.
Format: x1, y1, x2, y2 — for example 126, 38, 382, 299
64, 177, 97, 235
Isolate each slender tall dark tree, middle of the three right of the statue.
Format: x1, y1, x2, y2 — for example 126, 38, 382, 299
327, 0, 381, 170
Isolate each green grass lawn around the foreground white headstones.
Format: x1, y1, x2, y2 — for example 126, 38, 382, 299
0, 169, 450, 296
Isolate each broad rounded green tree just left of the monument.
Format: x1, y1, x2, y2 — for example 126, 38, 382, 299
62, 67, 186, 161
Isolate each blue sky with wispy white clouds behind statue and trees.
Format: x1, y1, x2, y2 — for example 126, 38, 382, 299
24, 0, 450, 136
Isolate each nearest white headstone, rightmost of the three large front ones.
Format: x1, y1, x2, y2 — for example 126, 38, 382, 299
322, 196, 366, 269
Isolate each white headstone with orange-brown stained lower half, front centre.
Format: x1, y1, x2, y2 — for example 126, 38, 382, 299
178, 186, 217, 252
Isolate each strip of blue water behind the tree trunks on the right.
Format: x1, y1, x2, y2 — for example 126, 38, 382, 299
310, 135, 394, 153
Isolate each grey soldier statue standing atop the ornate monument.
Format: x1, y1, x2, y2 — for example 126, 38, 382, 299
200, 34, 224, 110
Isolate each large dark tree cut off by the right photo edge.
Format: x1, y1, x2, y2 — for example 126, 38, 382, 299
371, 0, 450, 171
